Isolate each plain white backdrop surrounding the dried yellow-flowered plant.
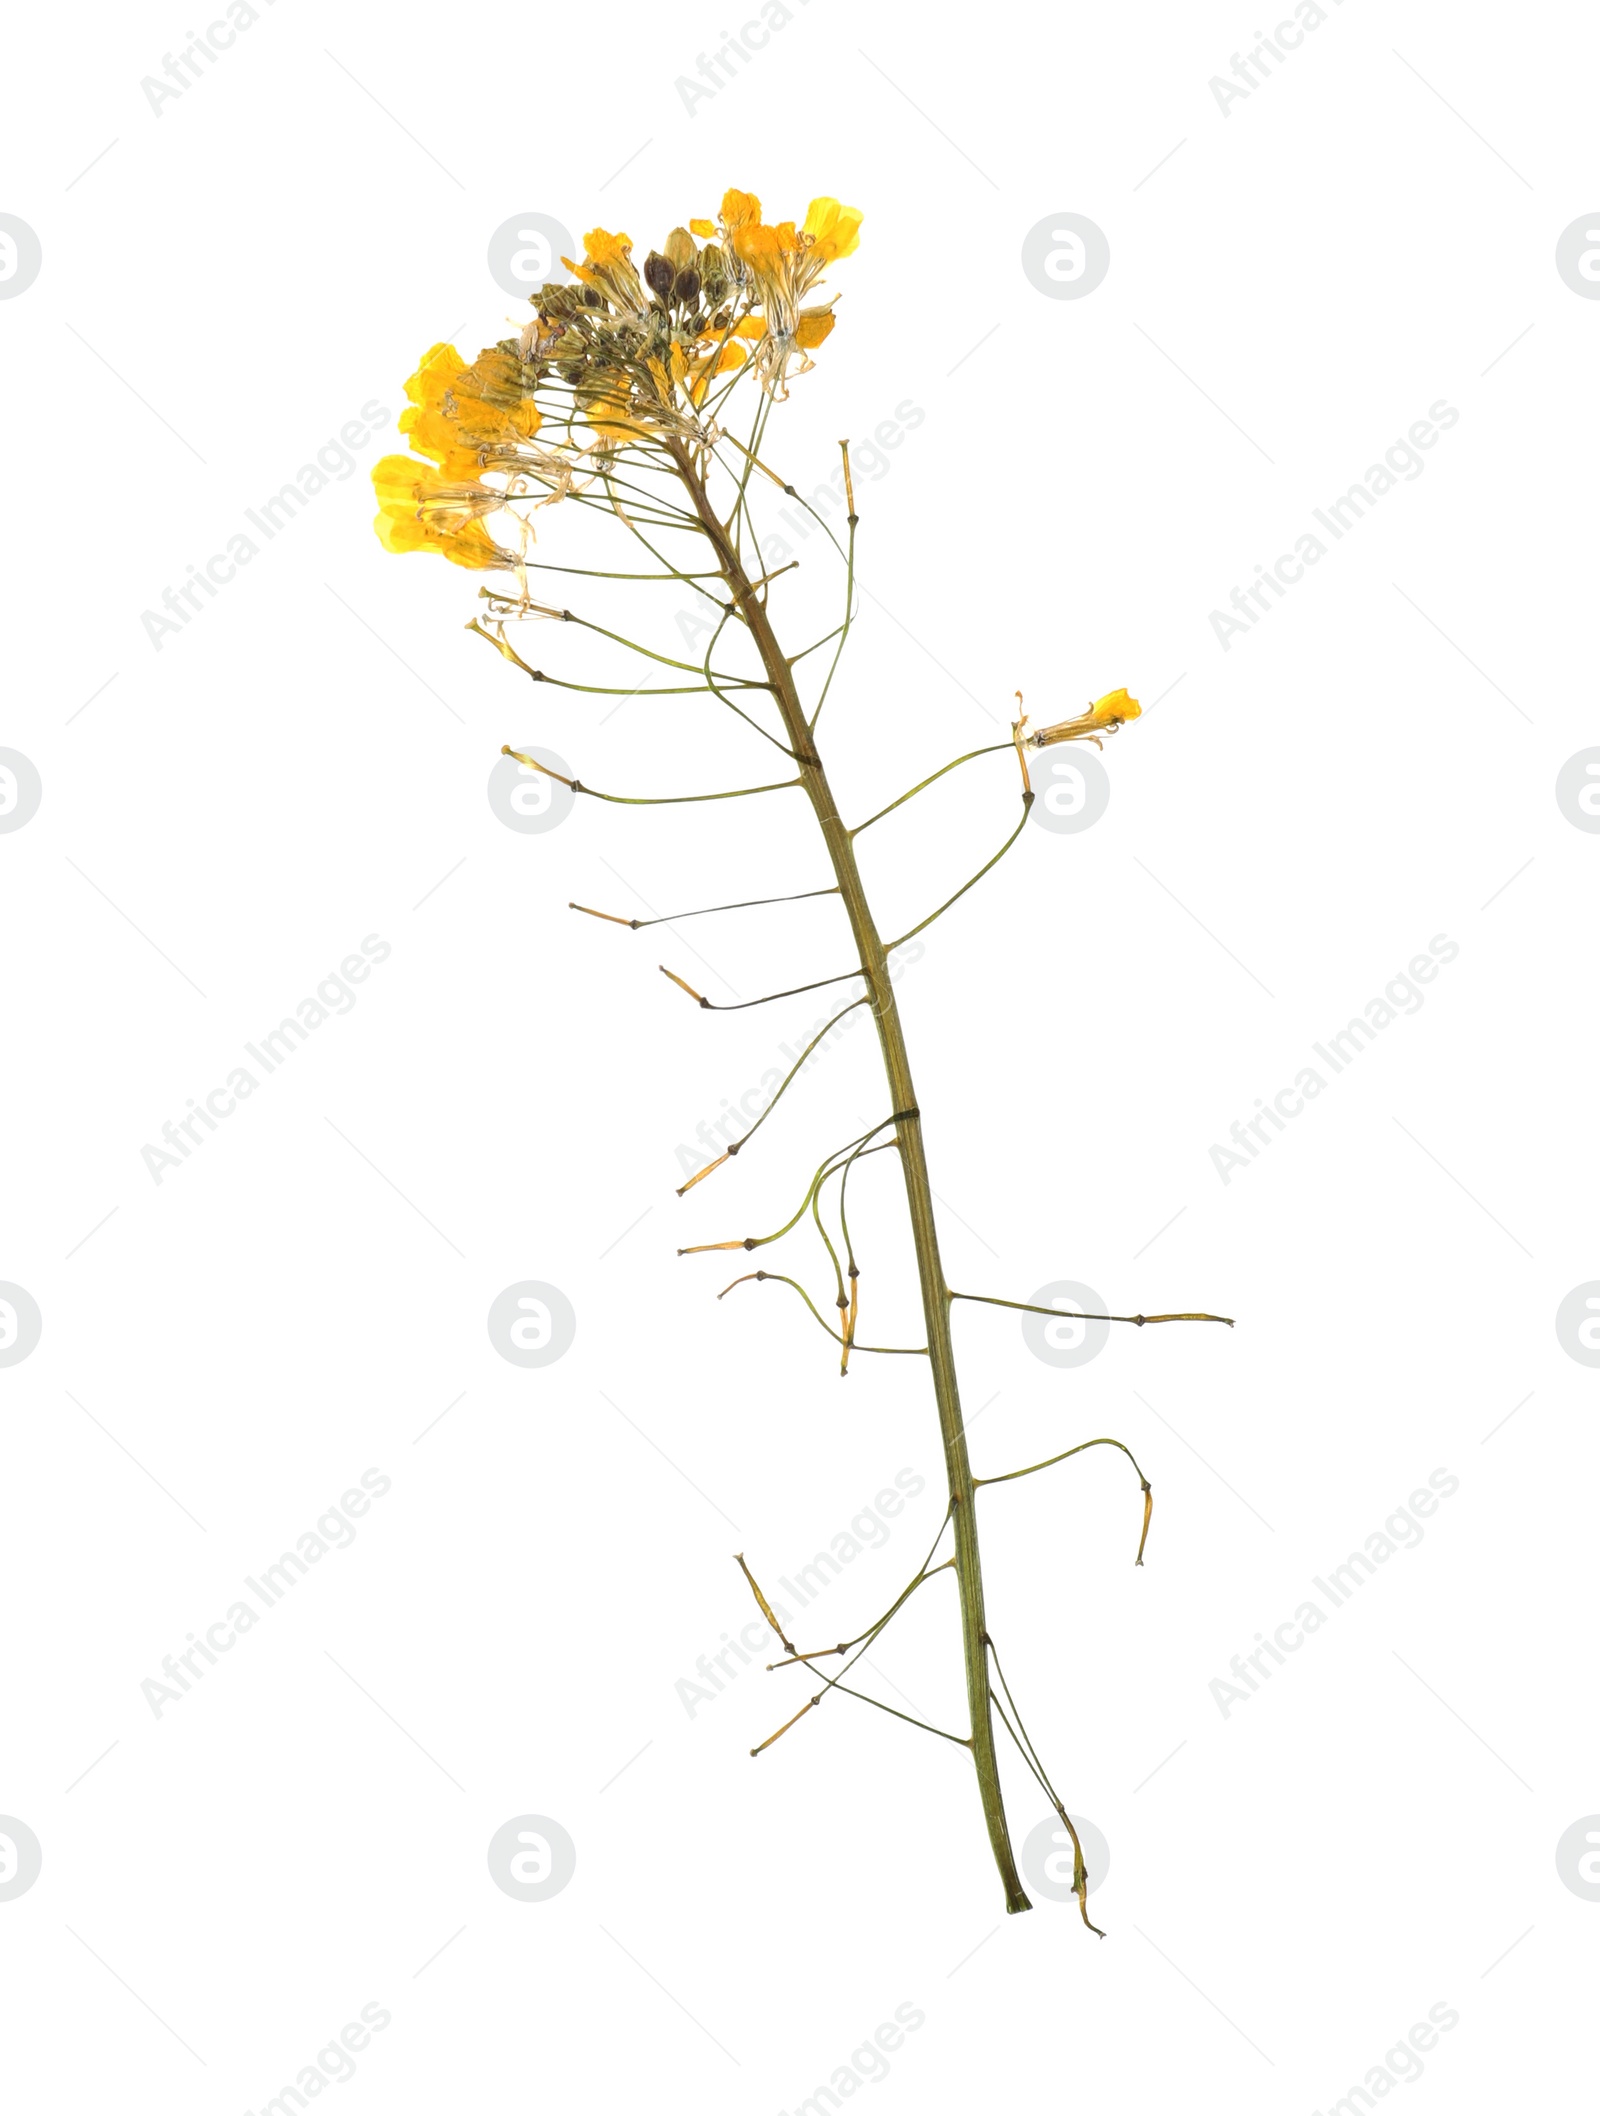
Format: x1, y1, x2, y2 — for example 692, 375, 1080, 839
0, 0, 1600, 2116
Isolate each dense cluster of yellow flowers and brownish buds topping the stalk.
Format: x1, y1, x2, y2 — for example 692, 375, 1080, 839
372, 190, 861, 569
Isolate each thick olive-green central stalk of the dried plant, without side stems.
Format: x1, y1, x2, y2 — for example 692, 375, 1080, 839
671, 444, 1033, 1911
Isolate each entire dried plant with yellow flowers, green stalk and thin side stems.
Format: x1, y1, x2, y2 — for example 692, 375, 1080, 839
372, 190, 1230, 1930
